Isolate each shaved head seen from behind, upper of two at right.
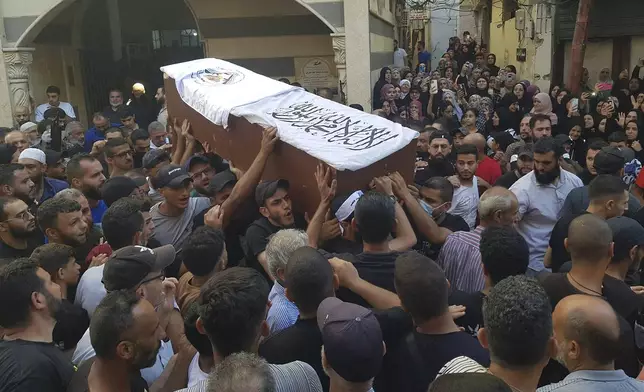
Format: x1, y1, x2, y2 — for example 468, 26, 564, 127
565, 214, 613, 269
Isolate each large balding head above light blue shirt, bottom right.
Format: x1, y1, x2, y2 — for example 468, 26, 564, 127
552, 295, 620, 368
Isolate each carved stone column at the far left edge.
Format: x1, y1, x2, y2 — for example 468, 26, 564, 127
3, 48, 35, 113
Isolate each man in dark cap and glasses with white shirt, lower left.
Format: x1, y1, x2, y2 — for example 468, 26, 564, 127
72, 245, 183, 385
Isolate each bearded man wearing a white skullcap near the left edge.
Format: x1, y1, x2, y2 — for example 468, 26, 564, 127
18, 148, 68, 204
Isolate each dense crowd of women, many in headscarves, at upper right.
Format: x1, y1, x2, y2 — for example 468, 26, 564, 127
372, 37, 644, 176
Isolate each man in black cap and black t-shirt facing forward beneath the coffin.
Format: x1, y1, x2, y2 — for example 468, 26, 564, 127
246, 180, 306, 282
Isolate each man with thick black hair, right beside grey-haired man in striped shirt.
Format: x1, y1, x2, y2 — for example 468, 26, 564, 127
449, 226, 530, 336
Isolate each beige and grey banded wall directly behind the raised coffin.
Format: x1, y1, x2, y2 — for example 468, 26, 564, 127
188, 0, 337, 87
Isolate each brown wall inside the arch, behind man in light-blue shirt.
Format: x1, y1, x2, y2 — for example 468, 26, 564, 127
30, 45, 87, 124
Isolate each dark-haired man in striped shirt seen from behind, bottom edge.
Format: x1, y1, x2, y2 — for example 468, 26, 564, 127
180, 267, 322, 392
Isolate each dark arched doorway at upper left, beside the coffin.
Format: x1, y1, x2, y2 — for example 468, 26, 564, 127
31, 0, 204, 123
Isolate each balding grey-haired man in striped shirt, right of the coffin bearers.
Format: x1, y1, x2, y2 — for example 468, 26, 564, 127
437, 187, 519, 293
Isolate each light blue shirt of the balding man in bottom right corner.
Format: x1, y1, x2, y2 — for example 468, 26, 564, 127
537, 370, 644, 392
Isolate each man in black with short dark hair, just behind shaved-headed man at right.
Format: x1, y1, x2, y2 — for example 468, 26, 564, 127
543, 174, 629, 272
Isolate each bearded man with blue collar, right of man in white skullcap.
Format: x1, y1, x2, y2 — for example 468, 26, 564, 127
67, 154, 107, 224
